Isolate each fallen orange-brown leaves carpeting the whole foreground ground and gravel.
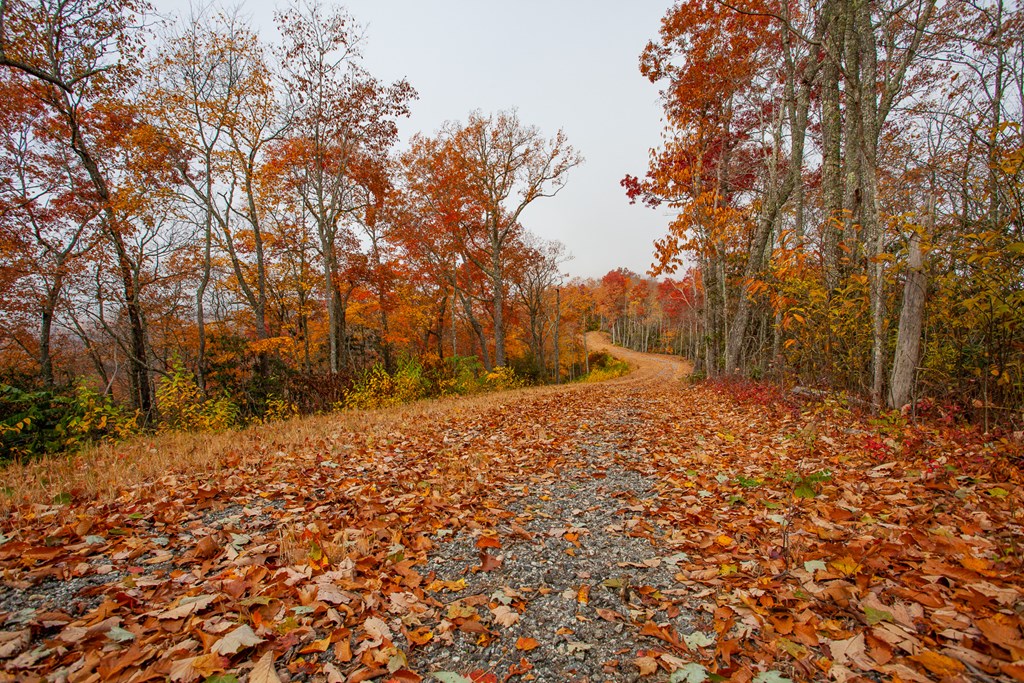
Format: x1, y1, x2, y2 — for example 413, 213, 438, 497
0, 342, 1024, 683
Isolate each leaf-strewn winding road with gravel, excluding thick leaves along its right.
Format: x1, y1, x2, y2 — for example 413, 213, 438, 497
0, 335, 688, 683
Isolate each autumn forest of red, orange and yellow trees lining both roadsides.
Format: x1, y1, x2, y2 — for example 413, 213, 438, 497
0, 0, 1024, 457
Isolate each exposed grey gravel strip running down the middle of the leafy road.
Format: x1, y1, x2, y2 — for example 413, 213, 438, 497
411, 387, 694, 683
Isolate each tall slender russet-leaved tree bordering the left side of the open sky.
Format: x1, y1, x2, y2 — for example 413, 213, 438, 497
278, 3, 415, 373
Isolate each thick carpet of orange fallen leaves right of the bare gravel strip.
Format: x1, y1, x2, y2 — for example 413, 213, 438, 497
606, 386, 1024, 681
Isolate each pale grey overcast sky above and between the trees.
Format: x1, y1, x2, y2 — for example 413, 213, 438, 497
157, 0, 671, 276
